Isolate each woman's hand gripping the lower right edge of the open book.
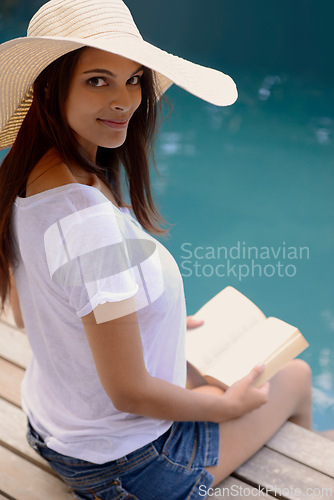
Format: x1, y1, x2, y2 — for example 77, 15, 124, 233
224, 365, 270, 418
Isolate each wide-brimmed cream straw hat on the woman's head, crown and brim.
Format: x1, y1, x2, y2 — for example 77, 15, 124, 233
0, 0, 237, 149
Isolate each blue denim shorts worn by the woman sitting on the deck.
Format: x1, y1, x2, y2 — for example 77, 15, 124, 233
27, 421, 219, 500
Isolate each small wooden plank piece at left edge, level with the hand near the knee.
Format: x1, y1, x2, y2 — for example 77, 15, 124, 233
0, 358, 24, 406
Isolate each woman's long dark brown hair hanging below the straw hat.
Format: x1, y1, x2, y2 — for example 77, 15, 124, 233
0, 47, 168, 312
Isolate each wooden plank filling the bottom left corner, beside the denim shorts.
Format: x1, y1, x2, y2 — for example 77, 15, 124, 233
0, 447, 73, 500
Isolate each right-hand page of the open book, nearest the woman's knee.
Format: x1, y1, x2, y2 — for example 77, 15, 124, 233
206, 318, 299, 385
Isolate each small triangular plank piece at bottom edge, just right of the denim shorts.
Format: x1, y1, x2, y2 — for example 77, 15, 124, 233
214, 476, 272, 500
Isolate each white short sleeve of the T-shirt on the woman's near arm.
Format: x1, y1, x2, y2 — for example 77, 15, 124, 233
44, 201, 138, 317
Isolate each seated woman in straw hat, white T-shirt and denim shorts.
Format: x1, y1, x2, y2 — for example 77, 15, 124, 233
0, 0, 311, 500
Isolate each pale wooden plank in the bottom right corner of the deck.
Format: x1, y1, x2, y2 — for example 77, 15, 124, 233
236, 447, 334, 500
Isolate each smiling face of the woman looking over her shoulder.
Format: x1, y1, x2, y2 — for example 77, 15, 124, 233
65, 47, 144, 161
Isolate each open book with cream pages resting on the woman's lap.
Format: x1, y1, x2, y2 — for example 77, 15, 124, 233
186, 286, 309, 387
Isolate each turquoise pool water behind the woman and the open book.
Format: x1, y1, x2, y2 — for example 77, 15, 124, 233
154, 70, 334, 429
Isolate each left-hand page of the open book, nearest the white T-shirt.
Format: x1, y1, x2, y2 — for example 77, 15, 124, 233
186, 286, 265, 372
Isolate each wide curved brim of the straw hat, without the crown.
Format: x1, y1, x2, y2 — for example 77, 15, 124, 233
0, 35, 238, 149
